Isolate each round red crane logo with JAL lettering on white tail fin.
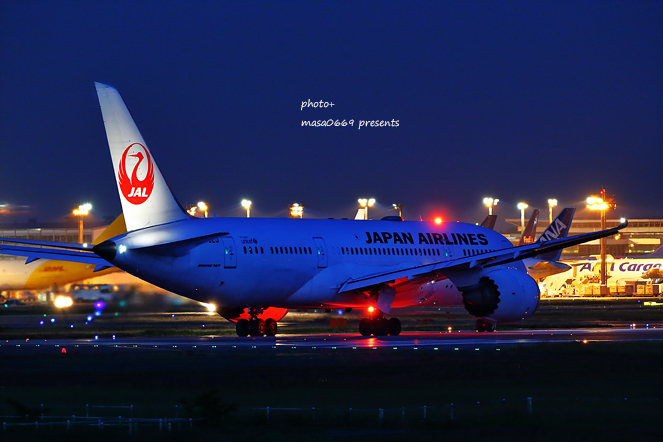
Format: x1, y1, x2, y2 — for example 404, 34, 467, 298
117, 143, 154, 204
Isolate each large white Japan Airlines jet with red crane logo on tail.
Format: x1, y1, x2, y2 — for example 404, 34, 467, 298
0, 83, 628, 336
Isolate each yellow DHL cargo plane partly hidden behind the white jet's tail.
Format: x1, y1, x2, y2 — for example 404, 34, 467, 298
0, 215, 127, 291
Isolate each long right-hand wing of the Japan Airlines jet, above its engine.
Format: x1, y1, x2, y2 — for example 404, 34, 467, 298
339, 220, 628, 292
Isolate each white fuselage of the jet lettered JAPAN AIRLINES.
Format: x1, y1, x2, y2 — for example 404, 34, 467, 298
110, 218, 524, 308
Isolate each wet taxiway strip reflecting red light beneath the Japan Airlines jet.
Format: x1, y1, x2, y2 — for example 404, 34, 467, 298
0, 327, 663, 354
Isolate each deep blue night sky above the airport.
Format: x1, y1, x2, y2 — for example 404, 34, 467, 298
0, 0, 663, 228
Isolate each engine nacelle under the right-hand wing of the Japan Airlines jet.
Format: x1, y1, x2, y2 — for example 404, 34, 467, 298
463, 268, 539, 322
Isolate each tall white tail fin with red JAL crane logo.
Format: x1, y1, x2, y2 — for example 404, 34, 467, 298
95, 83, 188, 231
